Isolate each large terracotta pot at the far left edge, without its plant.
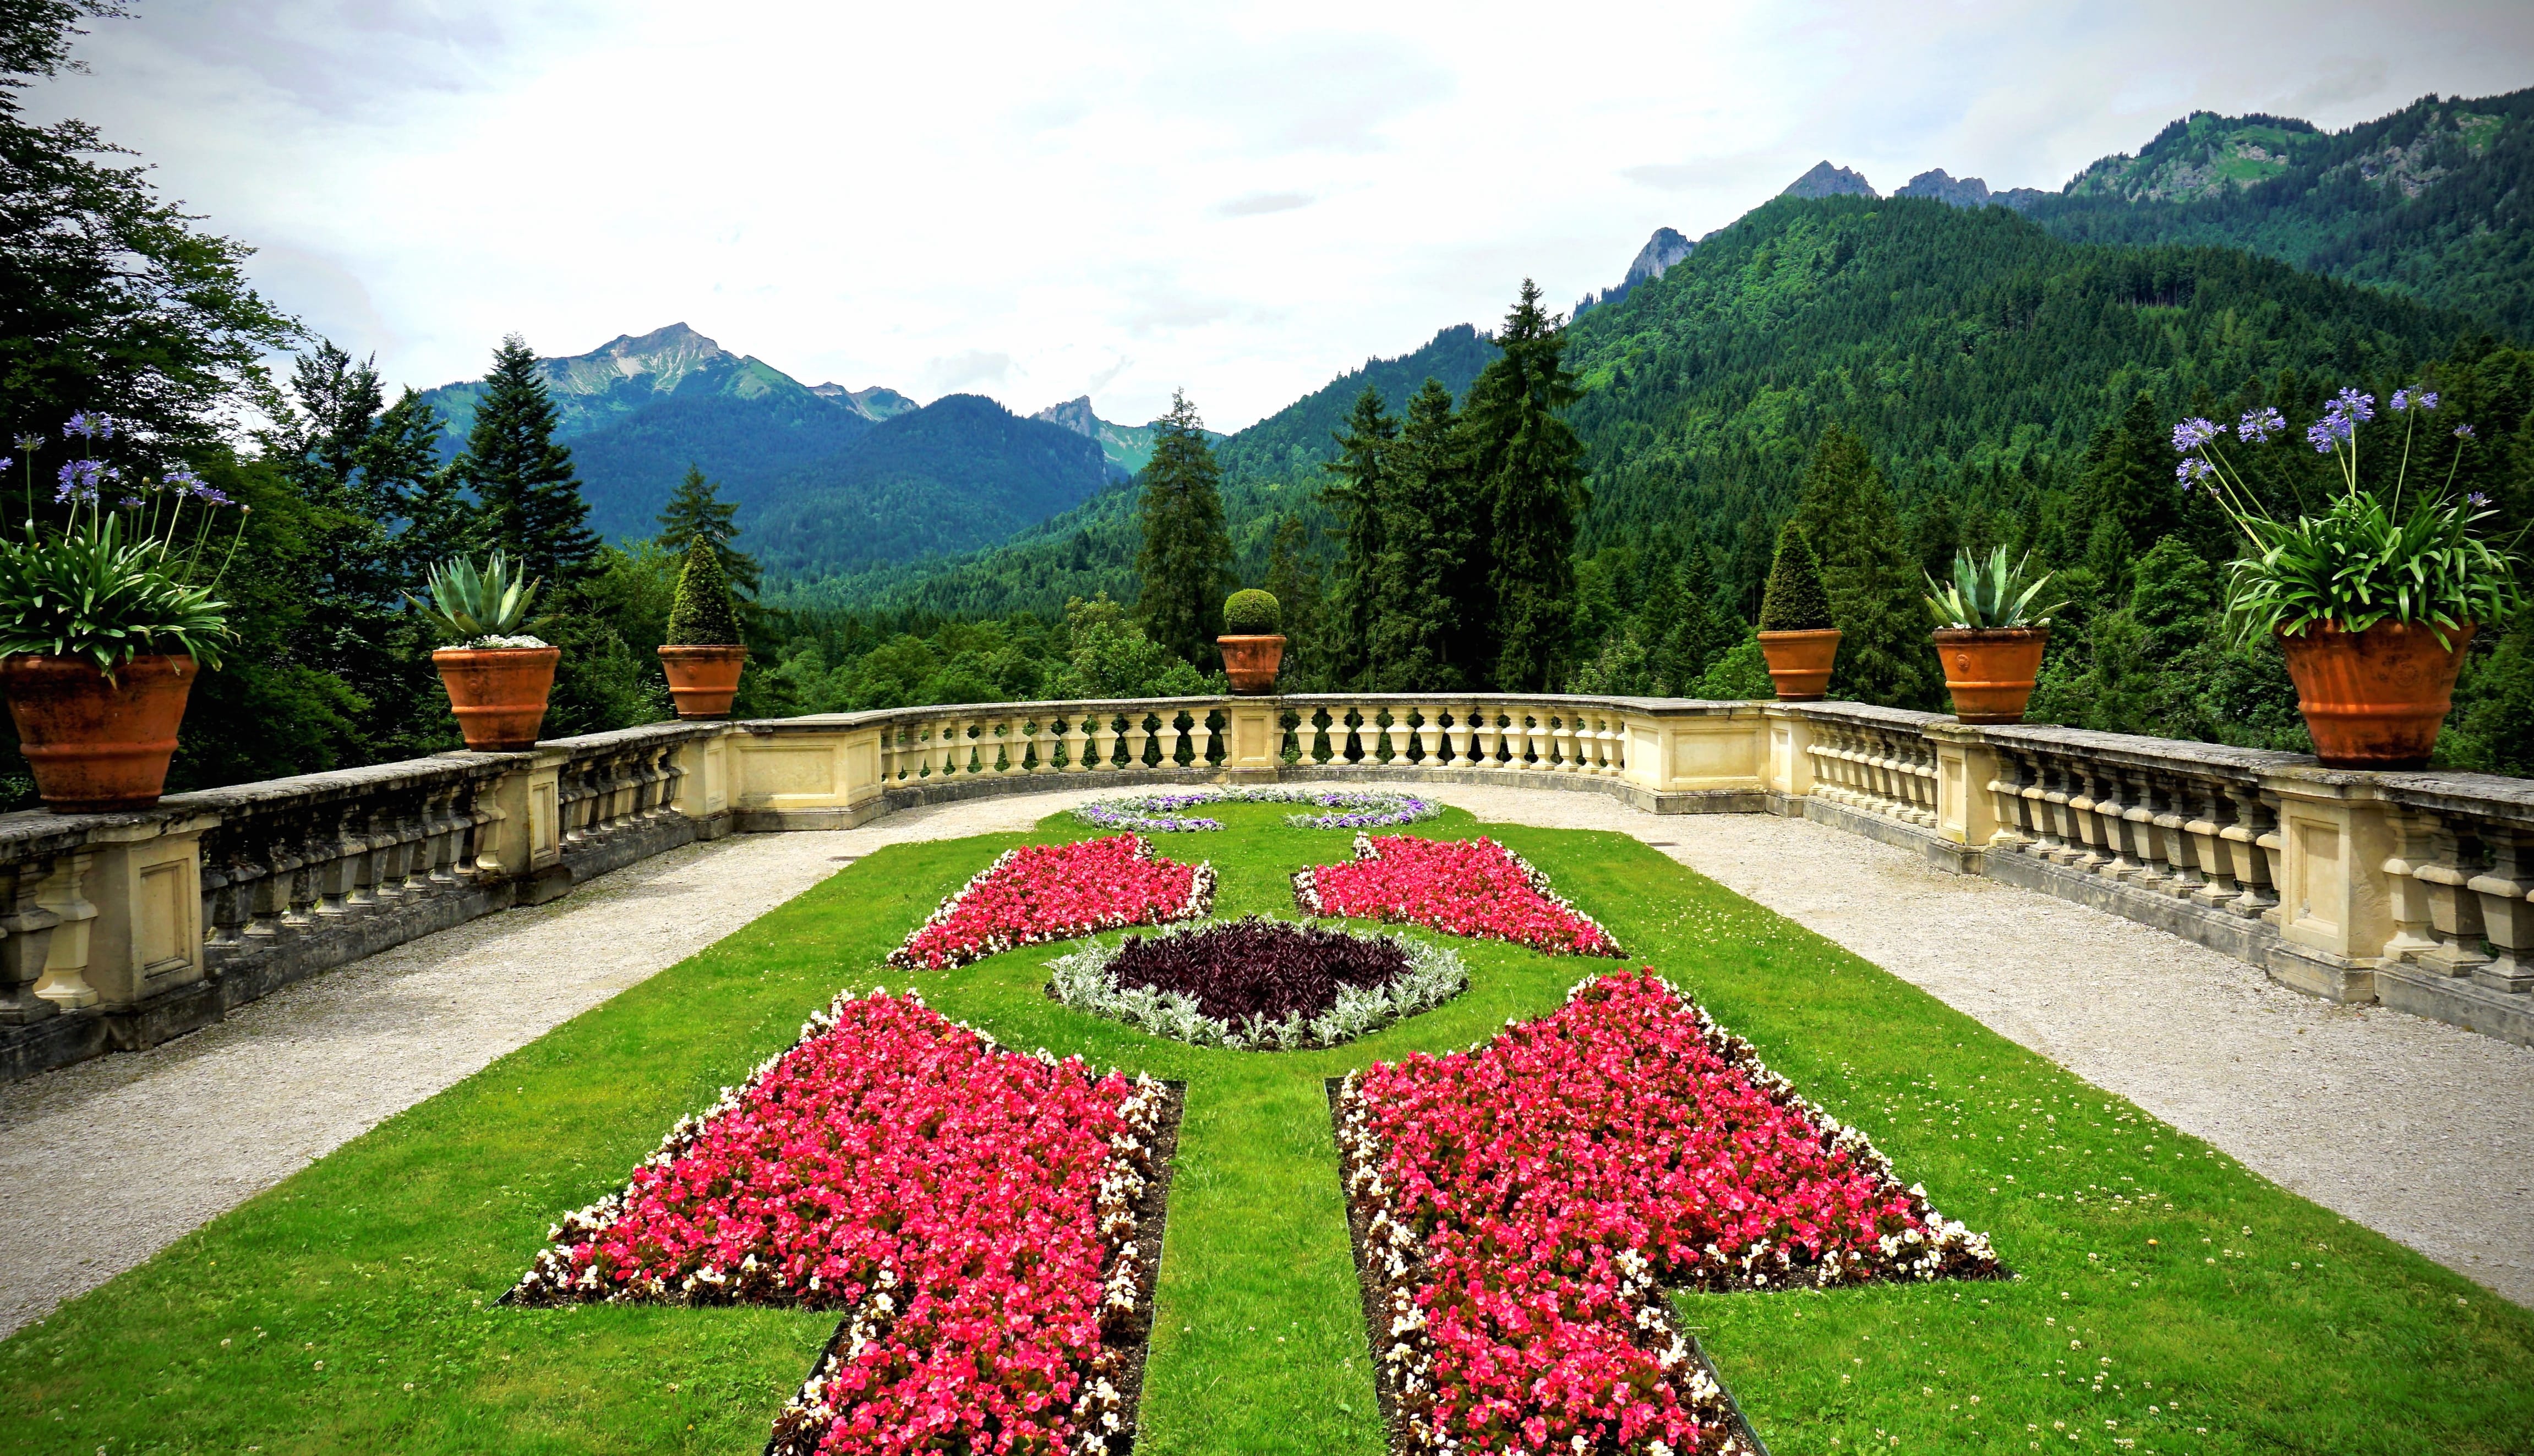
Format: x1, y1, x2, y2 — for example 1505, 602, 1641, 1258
0, 656, 195, 813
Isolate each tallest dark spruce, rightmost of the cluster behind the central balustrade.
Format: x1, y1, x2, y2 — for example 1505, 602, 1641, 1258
1462, 278, 1586, 691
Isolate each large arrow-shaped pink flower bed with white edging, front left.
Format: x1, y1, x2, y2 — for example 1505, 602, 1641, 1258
512, 993, 1171, 1456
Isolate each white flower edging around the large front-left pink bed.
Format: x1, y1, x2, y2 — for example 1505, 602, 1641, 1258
504, 985, 1171, 1456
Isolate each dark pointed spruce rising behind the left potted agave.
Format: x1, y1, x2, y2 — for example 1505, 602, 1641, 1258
451, 334, 598, 585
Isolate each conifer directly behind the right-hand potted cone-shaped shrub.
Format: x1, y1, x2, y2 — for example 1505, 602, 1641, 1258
1794, 425, 1943, 709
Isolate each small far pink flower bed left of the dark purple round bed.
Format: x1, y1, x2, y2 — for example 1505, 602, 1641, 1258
889, 833, 1214, 970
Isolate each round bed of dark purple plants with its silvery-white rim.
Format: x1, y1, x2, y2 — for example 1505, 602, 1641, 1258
1049, 917, 1470, 1051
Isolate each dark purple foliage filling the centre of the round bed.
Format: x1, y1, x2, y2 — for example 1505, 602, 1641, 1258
1110, 917, 1409, 1021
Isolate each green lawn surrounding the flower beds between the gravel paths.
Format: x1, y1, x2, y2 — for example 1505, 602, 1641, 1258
0, 805, 2534, 1456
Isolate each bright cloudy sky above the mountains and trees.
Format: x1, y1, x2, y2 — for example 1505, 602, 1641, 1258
28, 0, 2534, 430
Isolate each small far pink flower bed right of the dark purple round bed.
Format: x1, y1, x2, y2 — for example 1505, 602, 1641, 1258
1292, 833, 1619, 955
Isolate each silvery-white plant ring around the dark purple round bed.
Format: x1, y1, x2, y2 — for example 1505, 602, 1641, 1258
1046, 919, 1470, 1051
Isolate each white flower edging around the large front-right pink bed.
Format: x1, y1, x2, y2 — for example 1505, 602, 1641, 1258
1338, 967, 2007, 1456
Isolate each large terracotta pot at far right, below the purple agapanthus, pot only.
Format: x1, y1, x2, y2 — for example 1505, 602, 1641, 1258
2278, 623, 2476, 767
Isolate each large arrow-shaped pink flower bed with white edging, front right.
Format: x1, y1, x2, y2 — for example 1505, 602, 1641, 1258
1338, 970, 2002, 1456
